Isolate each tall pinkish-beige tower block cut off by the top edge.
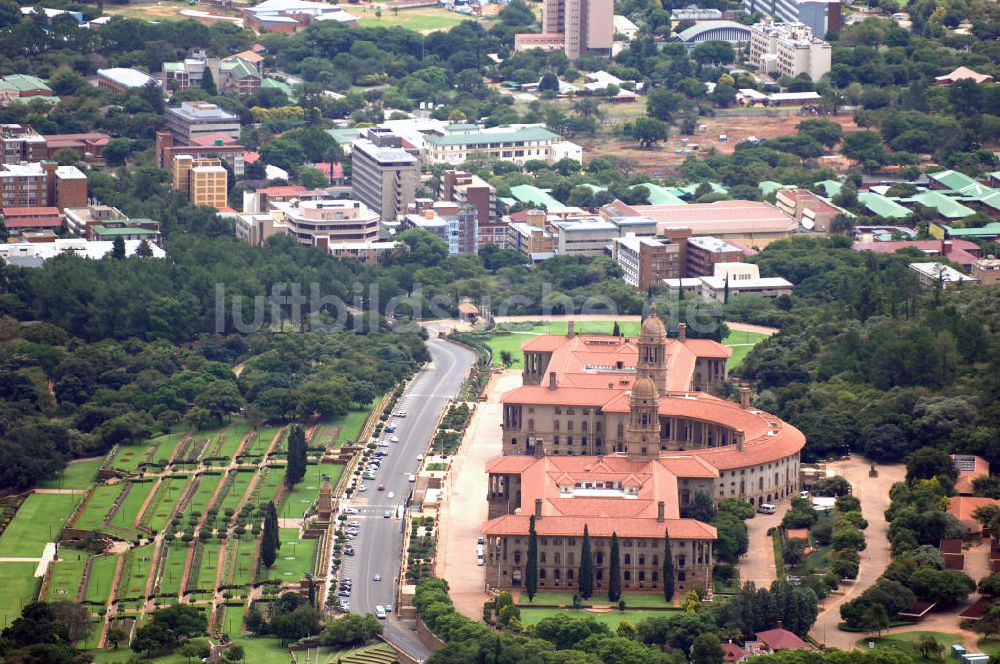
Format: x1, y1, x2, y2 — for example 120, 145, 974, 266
542, 0, 615, 60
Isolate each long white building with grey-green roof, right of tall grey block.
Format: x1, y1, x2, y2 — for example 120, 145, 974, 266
423, 124, 583, 165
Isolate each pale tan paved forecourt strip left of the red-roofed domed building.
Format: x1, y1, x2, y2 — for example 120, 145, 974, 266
435, 371, 521, 620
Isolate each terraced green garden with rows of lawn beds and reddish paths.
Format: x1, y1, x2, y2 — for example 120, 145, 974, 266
0, 410, 364, 664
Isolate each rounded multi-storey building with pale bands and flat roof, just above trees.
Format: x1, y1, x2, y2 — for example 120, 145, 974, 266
271, 200, 379, 252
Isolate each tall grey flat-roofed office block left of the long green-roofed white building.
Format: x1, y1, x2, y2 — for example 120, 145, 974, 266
351, 130, 420, 221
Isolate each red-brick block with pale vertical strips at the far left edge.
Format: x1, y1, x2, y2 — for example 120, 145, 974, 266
0, 161, 87, 210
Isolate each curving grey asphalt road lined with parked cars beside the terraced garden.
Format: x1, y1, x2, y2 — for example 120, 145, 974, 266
331, 329, 476, 660
